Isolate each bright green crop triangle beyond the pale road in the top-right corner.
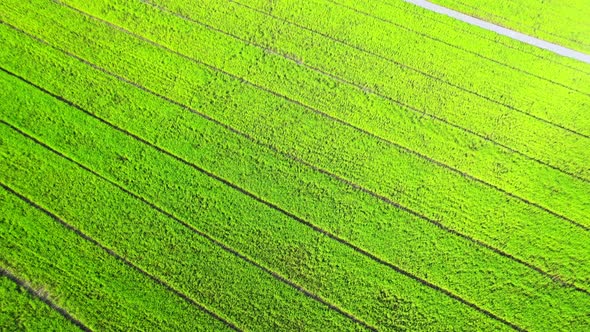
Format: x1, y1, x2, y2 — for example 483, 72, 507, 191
432, 0, 590, 53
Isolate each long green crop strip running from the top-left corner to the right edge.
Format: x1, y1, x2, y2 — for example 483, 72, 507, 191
2, 0, 588, 283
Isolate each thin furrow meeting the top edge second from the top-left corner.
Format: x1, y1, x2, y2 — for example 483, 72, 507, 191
140, 0, 590, 183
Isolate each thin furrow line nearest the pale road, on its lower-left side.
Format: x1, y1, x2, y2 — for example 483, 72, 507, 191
326, 0, 590, 92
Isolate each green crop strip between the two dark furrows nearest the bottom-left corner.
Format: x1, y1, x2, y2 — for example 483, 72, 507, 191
0, 188, 234, 331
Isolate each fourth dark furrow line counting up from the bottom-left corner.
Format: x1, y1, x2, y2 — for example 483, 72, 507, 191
0, 68, 524, 331
